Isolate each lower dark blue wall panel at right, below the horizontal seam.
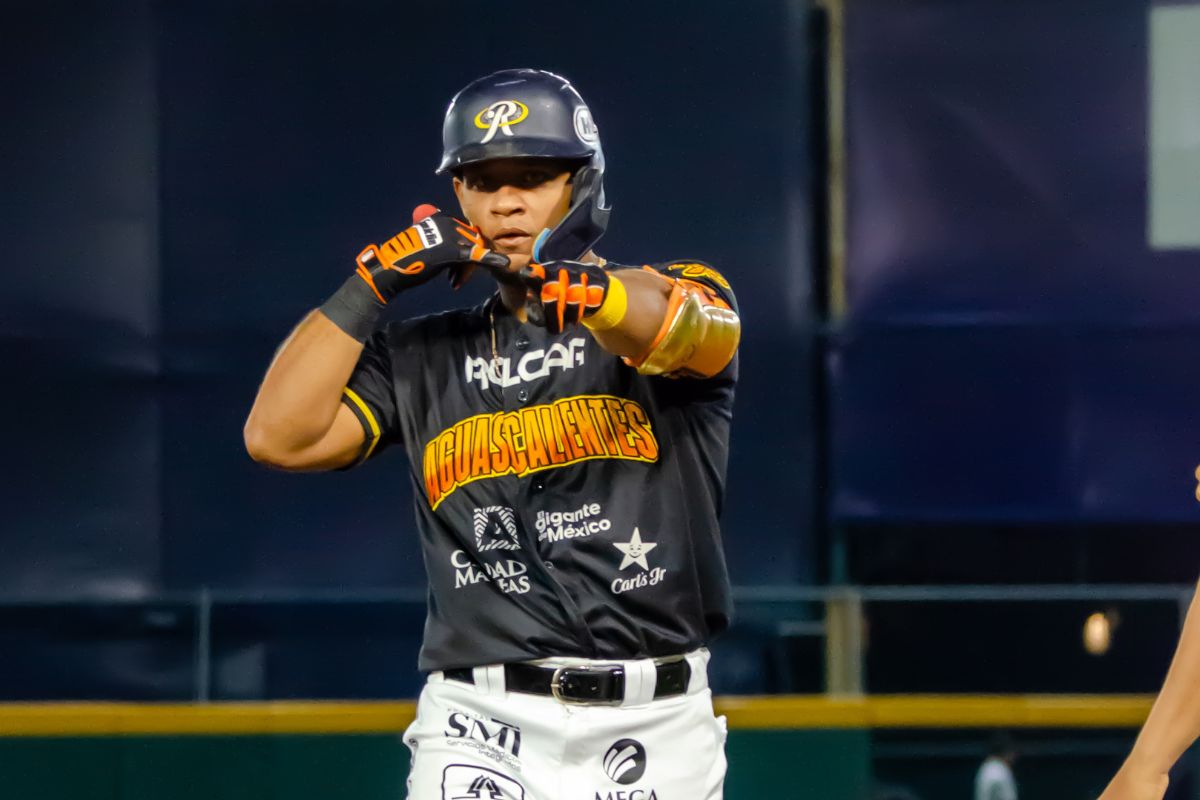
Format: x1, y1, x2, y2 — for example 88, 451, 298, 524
830, 326, 1200, 522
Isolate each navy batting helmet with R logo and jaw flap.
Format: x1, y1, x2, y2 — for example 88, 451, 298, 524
437, 70, 611, 261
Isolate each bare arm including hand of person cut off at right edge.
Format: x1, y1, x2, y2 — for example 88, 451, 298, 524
1100, 585, 1200, 800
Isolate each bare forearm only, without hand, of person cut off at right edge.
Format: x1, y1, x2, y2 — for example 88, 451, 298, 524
1128, 582, 1200, 775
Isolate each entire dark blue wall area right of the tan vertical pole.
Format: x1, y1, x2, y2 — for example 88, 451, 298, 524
828, 0, 1200, 523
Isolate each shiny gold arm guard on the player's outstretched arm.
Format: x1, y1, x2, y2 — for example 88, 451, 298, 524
629, 282, 742, 378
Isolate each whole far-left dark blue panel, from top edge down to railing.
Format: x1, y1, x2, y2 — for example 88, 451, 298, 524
0, 2, 163, 597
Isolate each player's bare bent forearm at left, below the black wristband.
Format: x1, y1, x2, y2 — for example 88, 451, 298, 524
245, 311, 362, 458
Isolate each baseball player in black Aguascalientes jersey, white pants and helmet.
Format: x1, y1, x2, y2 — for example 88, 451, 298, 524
245, 70, 740, 800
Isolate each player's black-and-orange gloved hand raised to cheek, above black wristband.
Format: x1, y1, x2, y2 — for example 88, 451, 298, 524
355, 204, 509, 305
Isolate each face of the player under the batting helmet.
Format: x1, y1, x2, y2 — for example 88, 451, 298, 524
454, 158, 571, 272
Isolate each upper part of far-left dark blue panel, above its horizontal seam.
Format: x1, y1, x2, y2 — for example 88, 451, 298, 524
0, 2, 160, 375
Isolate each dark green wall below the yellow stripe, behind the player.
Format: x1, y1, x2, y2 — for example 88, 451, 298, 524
0, 730, 870, 800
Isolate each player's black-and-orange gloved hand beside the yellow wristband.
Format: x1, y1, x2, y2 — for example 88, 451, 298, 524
521, 261, 608, 333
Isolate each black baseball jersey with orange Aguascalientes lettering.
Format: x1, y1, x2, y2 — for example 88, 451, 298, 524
333, 261, 737, 670
